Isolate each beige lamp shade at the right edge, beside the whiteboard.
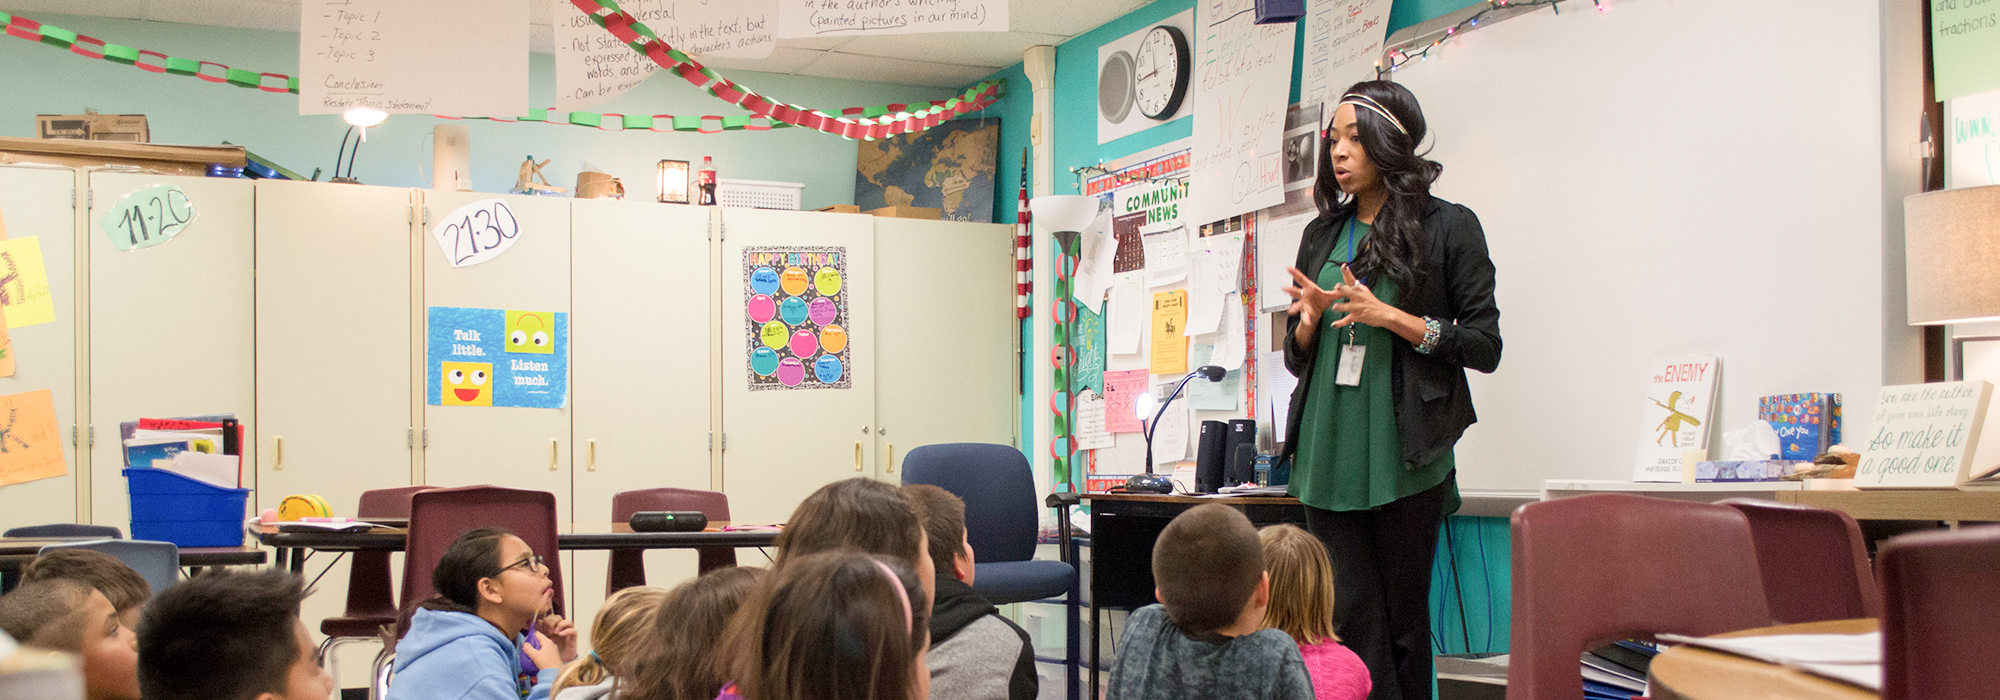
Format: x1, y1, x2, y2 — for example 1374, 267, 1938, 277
1912, 186, 2000, 326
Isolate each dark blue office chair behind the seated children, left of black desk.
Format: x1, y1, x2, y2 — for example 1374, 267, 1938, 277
902, 442, 1076, 606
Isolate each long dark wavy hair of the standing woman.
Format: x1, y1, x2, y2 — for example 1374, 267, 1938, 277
1312, 80, 1444, 284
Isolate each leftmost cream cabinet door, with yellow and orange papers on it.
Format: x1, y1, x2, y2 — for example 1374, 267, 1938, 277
0, 168, 80, 530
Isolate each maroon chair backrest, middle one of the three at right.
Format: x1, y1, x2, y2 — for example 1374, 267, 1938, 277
1720, 498, 1882, 624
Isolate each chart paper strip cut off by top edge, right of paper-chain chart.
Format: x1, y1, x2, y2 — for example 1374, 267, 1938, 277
778, 0, 1008, 38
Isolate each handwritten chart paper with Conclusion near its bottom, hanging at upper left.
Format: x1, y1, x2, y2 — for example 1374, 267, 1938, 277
298, 0, 528, 118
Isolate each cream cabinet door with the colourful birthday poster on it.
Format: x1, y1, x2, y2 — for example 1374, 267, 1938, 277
716, 208, 876, 524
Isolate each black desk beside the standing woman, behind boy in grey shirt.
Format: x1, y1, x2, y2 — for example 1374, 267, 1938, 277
1062, 494, 1306, 698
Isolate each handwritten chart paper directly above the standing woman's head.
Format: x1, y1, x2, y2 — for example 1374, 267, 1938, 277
1298, 0, 1390, 106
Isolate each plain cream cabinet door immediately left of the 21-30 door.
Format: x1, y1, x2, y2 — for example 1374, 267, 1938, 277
256, 180, 414, 508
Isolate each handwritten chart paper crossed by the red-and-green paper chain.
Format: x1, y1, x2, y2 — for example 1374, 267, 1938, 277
542, 0, 778, 112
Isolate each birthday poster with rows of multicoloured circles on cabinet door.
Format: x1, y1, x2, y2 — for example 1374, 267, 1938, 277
744, 246, 854, 392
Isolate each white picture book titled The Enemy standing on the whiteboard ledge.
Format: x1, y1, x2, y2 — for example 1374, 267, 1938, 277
1632, 354, 1722, 482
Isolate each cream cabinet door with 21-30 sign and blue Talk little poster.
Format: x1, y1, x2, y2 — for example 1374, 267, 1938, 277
412, 190, 570, 524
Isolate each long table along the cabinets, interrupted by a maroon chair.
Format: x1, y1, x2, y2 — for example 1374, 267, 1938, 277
254, 522, 778, 574
